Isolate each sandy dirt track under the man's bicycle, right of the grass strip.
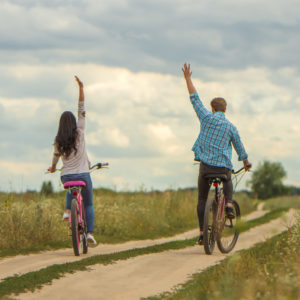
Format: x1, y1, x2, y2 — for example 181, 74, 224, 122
17, 210, 294, 300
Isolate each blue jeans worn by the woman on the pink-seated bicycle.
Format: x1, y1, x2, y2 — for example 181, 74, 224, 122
60, 173, 95, 233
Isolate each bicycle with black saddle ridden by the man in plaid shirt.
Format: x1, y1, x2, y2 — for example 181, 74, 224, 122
203, 167, 245, 254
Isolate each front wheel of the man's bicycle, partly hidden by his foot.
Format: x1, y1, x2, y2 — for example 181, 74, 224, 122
216, 200, 241, 253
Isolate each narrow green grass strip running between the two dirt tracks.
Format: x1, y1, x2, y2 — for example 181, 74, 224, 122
0, 206, 290, 298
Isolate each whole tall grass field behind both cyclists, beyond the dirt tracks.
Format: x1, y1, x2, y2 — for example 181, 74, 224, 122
0, 189, 256, 256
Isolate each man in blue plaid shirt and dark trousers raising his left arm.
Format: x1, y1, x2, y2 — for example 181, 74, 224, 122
182, 64, 252, 245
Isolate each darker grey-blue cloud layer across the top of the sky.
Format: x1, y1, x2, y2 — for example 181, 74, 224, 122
0, 0, 300, 76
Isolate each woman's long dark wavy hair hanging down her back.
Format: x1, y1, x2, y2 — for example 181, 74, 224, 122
55, 111, 78, 158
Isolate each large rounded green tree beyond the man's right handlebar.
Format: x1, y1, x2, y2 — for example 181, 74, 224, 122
248, 160, 288, 199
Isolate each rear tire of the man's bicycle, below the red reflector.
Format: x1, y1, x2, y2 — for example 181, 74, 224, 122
203, 198, 216, 255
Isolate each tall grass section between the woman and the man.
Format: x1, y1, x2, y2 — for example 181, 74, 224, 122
95, 190, 197, 240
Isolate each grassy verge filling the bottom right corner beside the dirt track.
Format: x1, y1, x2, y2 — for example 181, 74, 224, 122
147, 213, 300, 300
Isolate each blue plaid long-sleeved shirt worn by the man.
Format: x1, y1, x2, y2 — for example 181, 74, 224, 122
190, 93, 248, 170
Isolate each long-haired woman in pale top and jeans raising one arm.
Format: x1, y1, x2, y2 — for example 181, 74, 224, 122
49, 76, 97, 246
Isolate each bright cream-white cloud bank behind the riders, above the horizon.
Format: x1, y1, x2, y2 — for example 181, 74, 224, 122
0, 64, 300, 189
